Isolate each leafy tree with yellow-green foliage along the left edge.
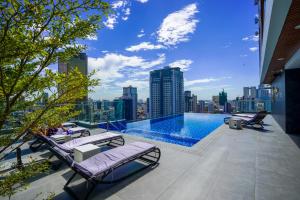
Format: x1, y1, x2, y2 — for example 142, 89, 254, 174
0, 0, 110, 197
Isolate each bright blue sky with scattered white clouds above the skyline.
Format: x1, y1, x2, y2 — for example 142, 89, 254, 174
53, 0, 259, 100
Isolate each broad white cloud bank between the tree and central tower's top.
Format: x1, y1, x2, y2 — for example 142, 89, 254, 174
88, 53, 165, 84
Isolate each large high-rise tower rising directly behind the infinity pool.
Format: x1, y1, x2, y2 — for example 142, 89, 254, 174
150, 67, 184, 118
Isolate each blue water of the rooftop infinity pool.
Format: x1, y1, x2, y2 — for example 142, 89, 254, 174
99, 113, 228, 147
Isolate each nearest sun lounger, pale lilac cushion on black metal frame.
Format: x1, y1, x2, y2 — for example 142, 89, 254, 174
50, 142, 161, 199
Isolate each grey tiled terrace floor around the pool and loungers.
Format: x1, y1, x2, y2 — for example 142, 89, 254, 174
4, 116, 300, 200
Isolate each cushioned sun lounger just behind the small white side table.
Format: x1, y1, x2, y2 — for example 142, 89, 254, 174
30, 132, 125, 153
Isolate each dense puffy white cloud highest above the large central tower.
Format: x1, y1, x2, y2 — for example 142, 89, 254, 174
156, 3, 199, 45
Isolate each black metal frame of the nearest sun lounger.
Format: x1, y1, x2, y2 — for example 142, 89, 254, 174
49, 147, 161, 200
